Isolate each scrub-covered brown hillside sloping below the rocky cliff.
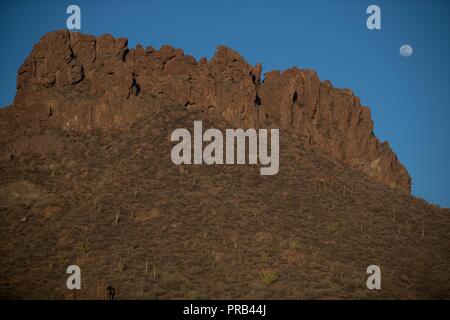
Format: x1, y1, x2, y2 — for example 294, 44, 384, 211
0, 108, 450, 299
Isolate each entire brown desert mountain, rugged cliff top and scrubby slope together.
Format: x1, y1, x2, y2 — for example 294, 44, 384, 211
0, 31, 450, 299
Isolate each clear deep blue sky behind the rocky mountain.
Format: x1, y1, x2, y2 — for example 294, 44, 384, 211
0, 0, 450, 207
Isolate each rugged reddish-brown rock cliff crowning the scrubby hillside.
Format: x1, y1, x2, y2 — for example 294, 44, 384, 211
7, 31, 411, 192
